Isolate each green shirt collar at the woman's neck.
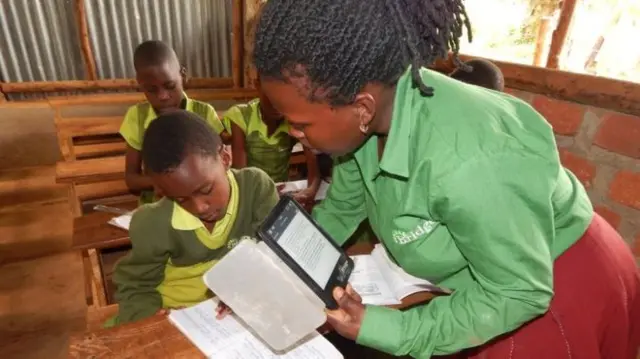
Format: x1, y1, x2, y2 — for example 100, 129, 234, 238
380, 67, 422, 178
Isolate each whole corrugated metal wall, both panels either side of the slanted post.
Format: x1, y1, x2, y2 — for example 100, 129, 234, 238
0, 0, 232, 82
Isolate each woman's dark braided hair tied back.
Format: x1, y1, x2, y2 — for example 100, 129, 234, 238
253, 0, 471, 106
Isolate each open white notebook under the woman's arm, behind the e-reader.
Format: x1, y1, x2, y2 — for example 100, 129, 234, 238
349, 244, 450, 305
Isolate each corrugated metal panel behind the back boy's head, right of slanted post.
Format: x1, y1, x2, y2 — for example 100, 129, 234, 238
85, 0, 231, 79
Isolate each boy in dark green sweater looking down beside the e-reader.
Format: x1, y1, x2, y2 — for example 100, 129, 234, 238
113, 110, 278, 324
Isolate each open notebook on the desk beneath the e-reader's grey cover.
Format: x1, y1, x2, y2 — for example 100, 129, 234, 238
169, 299, 343, 359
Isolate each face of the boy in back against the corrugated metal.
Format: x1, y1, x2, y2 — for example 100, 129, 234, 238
136, 61, 186, 115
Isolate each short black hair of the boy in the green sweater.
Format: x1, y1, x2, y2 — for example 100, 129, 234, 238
142, 110, 222, 173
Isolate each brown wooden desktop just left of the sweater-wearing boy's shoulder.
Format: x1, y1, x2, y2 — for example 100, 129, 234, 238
71, 211, 135, 250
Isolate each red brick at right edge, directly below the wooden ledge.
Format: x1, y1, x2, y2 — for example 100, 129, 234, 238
593, 113, 640, 158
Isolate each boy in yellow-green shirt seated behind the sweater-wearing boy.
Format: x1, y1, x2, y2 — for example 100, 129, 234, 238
120, 40, 224, 203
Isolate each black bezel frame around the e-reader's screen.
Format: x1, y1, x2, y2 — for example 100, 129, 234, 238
257, 195, 354, 309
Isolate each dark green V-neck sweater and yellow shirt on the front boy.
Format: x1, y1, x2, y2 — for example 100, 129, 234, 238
113, 168, 278, 324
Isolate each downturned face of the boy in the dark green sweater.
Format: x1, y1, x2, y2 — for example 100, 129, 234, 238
151, 146, 231, 223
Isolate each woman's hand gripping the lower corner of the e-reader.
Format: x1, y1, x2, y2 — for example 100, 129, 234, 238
327, 284, 365, 340
